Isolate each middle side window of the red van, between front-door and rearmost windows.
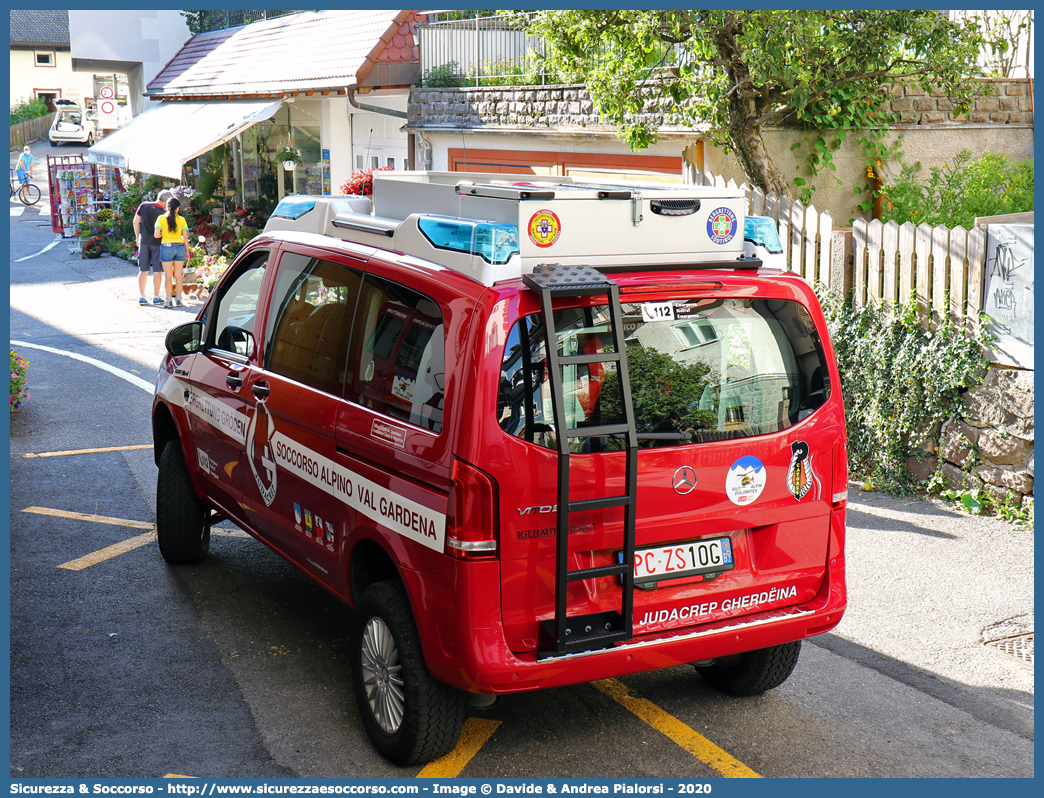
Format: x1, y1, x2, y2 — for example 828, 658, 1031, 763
264, 253, 362, 396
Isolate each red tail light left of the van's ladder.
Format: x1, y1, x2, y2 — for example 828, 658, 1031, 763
446, 460, 497, 560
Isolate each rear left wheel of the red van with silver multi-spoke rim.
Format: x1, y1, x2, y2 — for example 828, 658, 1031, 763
351, 580, 467, 766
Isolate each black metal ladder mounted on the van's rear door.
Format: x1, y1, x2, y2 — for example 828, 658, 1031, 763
523, 263, 638, 658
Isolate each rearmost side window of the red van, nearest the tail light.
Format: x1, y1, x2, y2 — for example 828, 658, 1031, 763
348, 276, 446, 432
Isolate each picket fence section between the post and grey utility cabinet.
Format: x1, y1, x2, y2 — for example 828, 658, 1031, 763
852, 219, 987, 327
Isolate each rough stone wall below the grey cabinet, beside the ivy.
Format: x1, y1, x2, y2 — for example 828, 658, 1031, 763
908, 367, 1034, 506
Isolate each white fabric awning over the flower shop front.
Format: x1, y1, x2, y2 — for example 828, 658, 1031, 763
87, 100, 283, 180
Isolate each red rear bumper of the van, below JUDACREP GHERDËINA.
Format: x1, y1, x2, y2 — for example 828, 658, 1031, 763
419, 558, 847, 695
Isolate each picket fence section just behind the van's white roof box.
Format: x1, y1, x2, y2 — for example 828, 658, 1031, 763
686, 168, 838, 285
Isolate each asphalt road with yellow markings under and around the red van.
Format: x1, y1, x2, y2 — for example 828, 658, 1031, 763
10, 167, 1034, 779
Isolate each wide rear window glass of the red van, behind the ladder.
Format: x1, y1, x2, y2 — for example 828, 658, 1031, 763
498, 299, 830, 451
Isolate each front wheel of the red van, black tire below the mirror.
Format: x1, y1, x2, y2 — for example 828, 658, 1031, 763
156, 438, 210, 565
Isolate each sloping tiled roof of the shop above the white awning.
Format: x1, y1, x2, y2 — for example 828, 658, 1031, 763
146, 10, 419, 98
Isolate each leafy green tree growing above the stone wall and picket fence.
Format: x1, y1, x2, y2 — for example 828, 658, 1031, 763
532, 9, 983, 195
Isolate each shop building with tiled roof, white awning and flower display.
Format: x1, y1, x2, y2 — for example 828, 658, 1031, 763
91, 10, 423, 207
